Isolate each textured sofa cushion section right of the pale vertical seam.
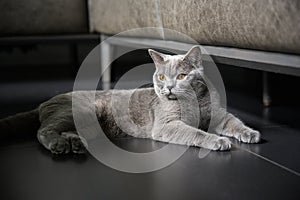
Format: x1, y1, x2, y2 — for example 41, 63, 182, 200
161, 0, 300, 53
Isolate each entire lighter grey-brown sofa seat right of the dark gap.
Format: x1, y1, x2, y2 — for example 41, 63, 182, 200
91, 0, 300, 54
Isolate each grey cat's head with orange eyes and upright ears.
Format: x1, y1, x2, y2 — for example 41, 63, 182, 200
149, 46, 204, 100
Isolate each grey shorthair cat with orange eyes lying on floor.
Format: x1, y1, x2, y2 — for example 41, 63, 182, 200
0, 46, 261, 154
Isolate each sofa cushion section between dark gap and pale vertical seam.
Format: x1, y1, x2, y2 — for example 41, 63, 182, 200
90, 0, 158, 34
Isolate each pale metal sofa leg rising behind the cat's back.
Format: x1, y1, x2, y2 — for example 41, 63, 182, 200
100, 35, 113, 90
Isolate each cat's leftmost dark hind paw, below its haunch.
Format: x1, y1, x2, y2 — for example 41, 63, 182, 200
49, 137, 70, 154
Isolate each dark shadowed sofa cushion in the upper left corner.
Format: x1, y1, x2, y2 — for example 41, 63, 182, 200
0, 0, 88, 36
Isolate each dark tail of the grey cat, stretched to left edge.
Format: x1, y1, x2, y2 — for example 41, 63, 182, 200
0, 108, 40, 141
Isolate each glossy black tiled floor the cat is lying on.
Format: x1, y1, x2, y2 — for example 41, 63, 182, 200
0, 91, 300, 200
